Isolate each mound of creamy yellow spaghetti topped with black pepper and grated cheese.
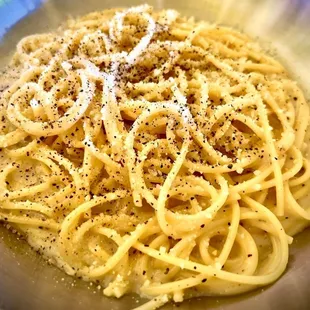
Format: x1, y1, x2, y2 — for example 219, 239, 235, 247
0, 5, 310, 309
